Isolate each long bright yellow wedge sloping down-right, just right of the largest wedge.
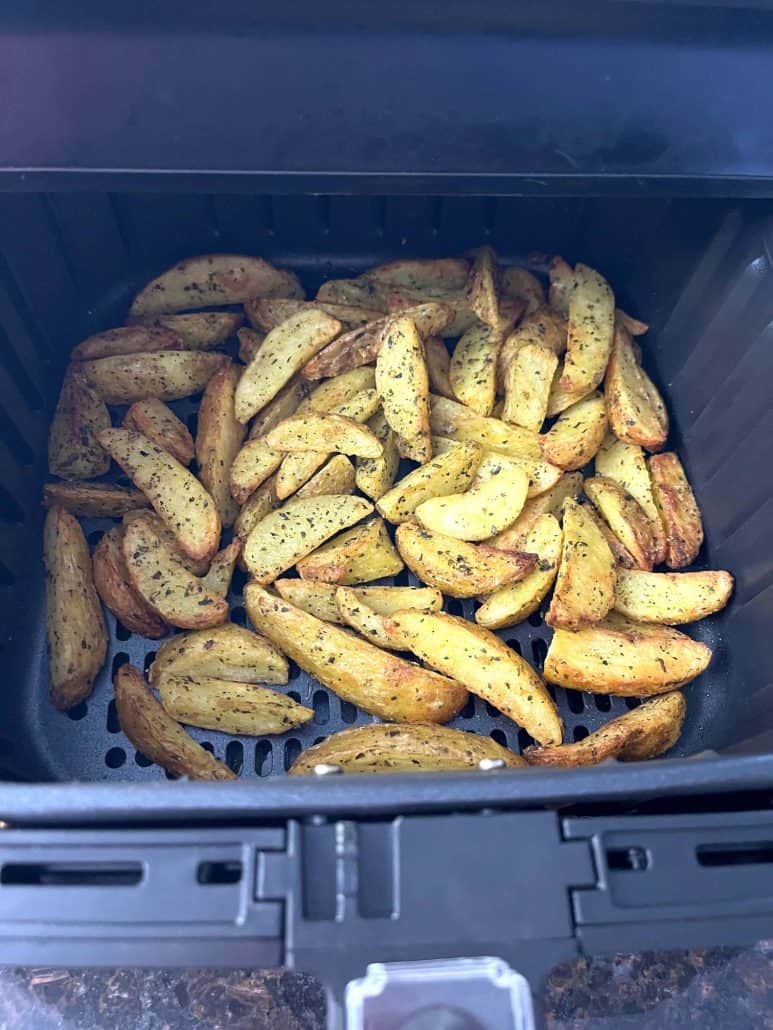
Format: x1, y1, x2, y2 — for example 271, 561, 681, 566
385, 612, 564, 744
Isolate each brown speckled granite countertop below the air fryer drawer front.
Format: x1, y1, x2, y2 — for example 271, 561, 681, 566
0, 941, 773, 1030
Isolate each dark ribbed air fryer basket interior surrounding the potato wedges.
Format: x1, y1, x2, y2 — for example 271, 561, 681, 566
0, 193, 773, 782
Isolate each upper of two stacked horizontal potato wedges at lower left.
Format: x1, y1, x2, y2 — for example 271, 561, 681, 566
150, 618, 295, 687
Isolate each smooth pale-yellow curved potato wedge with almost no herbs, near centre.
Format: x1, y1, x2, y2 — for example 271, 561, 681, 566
413, 454, 529, 541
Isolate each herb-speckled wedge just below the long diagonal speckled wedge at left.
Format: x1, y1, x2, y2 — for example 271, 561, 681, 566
123, 515, 228, 629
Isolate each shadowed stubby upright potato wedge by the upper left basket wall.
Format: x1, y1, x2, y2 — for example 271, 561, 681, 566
48, 365, 110, 479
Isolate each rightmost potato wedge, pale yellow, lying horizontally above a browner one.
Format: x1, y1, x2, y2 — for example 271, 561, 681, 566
614, 570, 734, 626
